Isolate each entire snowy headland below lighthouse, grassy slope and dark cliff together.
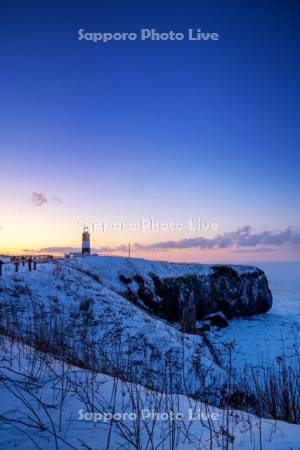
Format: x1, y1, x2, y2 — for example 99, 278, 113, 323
0, 257, 272, 402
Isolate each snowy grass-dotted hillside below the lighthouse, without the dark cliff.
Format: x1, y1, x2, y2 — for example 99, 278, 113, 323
0, 257, 223, 398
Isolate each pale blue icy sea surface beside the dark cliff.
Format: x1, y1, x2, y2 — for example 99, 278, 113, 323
212, 262, 300, 367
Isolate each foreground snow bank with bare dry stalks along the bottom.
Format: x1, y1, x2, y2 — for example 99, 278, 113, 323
0, 338, 300, 450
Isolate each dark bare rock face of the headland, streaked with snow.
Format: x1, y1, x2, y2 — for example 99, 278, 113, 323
120, 266, 272, 329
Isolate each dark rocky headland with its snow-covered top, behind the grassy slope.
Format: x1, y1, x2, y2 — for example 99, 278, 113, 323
69, 257, 272, 330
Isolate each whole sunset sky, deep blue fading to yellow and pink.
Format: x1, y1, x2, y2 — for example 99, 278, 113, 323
0, 0, 300, 262
